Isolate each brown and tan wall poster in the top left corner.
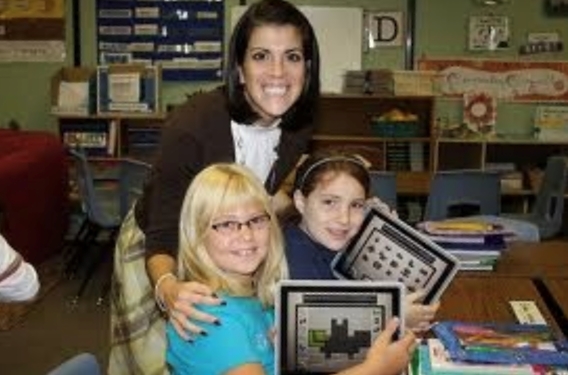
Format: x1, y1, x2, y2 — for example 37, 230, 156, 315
0, 0, 65, 63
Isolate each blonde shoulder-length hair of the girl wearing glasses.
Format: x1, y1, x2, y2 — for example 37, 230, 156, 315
178, 164, 288, 306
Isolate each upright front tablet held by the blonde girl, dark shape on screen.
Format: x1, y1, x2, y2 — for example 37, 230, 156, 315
276, 280, 405, 375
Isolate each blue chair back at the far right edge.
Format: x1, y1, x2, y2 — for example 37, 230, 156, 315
532, 156, 568, 238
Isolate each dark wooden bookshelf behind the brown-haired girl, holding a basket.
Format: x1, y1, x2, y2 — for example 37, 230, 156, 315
312, 94, 434, 195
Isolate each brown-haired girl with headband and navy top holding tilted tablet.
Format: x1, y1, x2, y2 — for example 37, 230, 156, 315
284, 150, 439, 331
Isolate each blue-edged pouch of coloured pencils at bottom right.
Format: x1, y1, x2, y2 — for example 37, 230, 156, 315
432, 321, 568, 366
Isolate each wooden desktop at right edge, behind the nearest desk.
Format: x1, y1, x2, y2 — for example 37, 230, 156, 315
489, 241, 568, 278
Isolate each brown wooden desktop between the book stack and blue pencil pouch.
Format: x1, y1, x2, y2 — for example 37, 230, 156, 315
436, 274, 563, 336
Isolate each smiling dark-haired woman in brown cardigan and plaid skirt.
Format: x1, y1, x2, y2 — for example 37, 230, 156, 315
109, 0, 319, 375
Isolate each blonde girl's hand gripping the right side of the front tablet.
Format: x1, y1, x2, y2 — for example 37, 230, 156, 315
361, 318, 416, 375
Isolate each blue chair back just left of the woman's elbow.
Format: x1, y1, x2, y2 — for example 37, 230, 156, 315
119, 159, 151, 219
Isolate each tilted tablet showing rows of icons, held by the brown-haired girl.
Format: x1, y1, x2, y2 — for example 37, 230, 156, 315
331, 209, 459, 304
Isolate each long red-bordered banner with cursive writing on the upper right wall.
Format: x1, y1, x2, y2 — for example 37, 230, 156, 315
418, 58, 568, 102
